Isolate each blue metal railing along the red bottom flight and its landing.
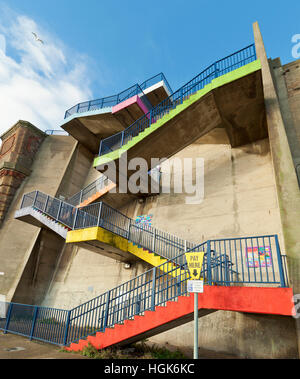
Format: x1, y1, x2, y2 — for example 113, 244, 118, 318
0, 236, 288, 345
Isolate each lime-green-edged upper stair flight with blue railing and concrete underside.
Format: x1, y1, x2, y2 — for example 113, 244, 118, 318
94, 45, 265, 172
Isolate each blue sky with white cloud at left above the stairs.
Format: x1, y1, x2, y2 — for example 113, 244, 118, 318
0, 0, 300, 135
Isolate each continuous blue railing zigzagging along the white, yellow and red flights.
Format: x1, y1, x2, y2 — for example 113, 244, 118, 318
9, 191, 289, 345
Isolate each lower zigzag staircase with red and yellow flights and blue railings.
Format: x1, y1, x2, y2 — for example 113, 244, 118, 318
13, 192, 294, 351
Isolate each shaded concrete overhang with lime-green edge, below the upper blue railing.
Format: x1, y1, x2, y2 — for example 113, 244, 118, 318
94, 61, 268, 191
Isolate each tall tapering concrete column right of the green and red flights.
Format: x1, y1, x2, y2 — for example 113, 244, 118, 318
253, 22, 300, 354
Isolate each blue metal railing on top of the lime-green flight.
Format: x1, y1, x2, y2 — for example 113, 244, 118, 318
99, 44, 256, 156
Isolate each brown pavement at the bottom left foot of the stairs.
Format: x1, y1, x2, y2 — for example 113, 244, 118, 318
0, 332, 90, 359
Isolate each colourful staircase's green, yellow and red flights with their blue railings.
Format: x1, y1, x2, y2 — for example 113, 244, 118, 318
9, 46, 295, 351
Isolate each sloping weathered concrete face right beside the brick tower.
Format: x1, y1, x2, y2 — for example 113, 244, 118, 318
0, 136, 77, 301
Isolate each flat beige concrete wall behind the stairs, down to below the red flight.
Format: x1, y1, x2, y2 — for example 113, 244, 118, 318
39, 129, 297, 358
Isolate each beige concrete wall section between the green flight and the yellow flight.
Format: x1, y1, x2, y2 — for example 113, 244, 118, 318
123, 128, 281, 243
